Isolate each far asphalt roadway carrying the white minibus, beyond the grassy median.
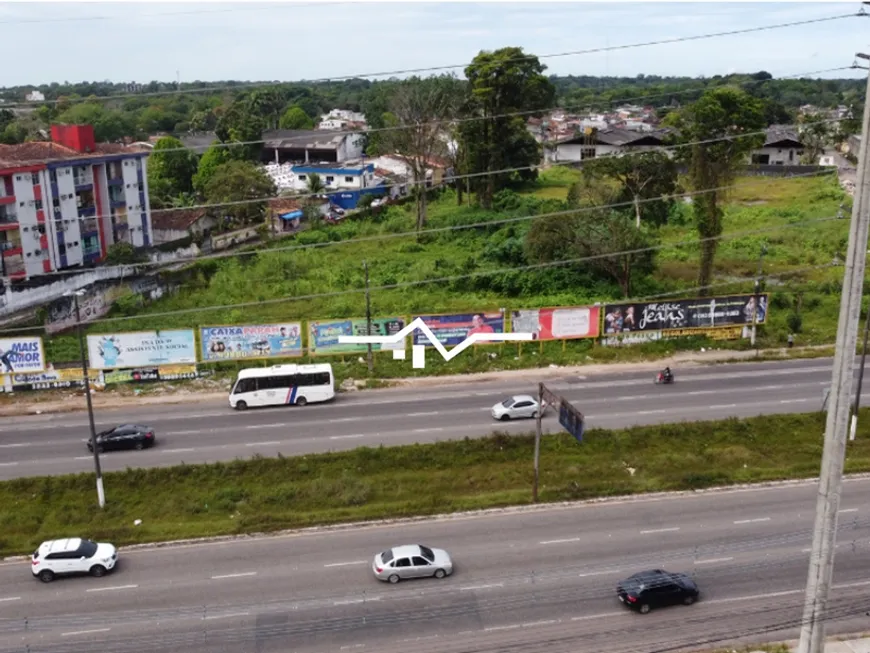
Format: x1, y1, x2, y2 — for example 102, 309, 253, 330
0, 359, 870, 480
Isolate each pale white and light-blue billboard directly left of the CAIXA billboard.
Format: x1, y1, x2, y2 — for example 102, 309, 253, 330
88, 329, 196, 370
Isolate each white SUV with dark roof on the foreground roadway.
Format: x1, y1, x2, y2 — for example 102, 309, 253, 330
30, 537, 118, 583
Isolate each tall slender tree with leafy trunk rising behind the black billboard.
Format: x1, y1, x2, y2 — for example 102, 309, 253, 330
669, 86, 766, 296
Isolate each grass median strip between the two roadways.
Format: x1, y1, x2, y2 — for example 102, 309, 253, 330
0, 409, 870, 556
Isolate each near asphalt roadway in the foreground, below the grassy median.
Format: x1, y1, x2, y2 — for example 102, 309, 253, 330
0, 480, 870, 653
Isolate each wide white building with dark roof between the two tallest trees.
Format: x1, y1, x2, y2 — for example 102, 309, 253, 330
545, 127, 670, 162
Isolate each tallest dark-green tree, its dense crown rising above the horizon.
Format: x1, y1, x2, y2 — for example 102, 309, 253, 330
462, 47, 556, 208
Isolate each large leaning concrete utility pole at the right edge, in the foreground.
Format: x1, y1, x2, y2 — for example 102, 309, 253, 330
797, 53, 870, 653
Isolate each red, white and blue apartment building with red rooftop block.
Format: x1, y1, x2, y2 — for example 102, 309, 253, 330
0, 125, 153, 280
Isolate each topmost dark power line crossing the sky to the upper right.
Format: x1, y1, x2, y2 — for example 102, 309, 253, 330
4, 7, 867, 107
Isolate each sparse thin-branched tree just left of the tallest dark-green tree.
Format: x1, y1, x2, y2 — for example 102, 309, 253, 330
381, 75, 462, 230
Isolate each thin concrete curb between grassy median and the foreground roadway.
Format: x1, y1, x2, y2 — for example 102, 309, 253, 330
3, 473, 870, 562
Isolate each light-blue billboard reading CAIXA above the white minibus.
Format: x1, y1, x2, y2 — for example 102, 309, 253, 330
199, 322, 302, 362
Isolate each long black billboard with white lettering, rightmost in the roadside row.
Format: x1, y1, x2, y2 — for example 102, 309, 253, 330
604, 294, 768, 336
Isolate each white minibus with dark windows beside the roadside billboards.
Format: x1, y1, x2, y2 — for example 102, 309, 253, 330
230, 363, 335, 410
